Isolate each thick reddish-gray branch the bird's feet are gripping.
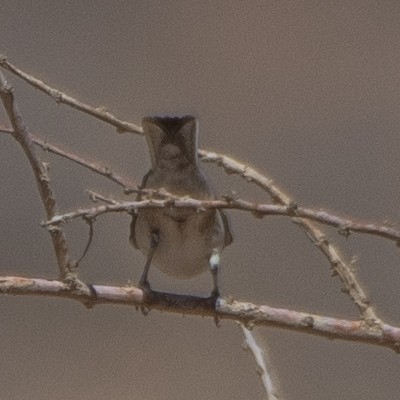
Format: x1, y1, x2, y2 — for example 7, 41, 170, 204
0, 277, 400, 352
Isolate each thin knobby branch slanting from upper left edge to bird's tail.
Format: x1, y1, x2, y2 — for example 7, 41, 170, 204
0, 54, 143, 135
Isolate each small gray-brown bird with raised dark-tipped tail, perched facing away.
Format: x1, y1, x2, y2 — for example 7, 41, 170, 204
130, 116, 232, 296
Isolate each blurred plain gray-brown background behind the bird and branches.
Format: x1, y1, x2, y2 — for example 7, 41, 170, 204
0, 0, 400, 400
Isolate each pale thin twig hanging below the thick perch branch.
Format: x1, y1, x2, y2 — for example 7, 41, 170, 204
238, 322, 283, 400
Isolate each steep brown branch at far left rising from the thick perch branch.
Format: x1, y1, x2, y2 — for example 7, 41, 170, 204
0, 72, 73, 279
